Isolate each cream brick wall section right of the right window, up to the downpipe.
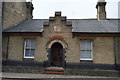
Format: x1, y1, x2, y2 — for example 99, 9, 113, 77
93, 37, 115, 64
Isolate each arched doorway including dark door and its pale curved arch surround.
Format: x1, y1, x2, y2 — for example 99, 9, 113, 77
46, 38, 68, 67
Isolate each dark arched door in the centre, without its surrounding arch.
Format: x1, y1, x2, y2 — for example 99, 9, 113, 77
50, 42, 64, 67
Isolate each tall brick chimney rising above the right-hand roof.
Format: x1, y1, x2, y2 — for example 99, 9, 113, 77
96, 0, 106, 20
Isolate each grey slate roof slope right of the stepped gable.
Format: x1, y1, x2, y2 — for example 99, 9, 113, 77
72, 19, 119, 33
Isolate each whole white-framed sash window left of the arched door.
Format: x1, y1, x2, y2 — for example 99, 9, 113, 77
24, 39, 35, 58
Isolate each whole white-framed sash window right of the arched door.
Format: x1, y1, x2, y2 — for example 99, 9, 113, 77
80, 40, 93, 60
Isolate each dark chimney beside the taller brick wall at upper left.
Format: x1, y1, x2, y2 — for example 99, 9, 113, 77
26, 2, 34, 19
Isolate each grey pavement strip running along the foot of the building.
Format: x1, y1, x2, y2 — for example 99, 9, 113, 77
2, 73, 120, 80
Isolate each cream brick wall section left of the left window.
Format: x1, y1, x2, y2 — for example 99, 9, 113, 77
8, 36, 24, 61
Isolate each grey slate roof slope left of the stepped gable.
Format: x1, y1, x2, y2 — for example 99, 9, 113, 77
3, 19, 46, 32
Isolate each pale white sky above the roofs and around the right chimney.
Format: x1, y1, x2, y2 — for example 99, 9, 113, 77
27, 0, 120, 19
